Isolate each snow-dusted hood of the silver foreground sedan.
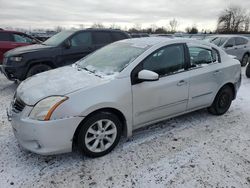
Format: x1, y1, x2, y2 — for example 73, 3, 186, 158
16, 66, 114, 106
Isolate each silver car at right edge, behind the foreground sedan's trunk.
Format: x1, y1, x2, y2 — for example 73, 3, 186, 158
211, 35, 250, 66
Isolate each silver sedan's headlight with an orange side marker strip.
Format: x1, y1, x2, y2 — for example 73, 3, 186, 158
29, 96, 68, 121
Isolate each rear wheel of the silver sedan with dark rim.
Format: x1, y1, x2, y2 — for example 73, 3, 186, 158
208, 85, 233, 115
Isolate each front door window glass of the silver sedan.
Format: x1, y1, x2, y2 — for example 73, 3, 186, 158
143, 44, 185, 76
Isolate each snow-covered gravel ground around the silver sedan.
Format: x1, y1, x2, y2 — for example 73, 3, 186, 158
0, 69, 250, 188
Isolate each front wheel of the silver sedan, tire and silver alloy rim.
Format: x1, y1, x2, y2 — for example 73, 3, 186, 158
77, 112, 122, 158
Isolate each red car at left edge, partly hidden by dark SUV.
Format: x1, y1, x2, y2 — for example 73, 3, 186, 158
0, 30, 40, 64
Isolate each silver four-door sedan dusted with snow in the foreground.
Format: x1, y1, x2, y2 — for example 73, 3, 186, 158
8, 37, 241, 157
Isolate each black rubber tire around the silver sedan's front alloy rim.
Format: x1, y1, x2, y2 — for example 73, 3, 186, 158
77, 112, 122, 158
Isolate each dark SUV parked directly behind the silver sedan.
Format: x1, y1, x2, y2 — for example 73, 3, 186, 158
2, 29, 130, 80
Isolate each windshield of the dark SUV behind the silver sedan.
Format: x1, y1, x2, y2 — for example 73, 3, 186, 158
42, 31, 73, 46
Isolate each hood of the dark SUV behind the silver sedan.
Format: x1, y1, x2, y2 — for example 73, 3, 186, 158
5, 44, 54, 57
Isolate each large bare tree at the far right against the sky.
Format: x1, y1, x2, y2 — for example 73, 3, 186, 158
217, 6, 249, 33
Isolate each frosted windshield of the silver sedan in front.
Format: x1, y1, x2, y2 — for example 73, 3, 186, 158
76, 42, 150, 75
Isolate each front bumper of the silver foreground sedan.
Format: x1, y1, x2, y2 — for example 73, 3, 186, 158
8, 108, 83, 155
